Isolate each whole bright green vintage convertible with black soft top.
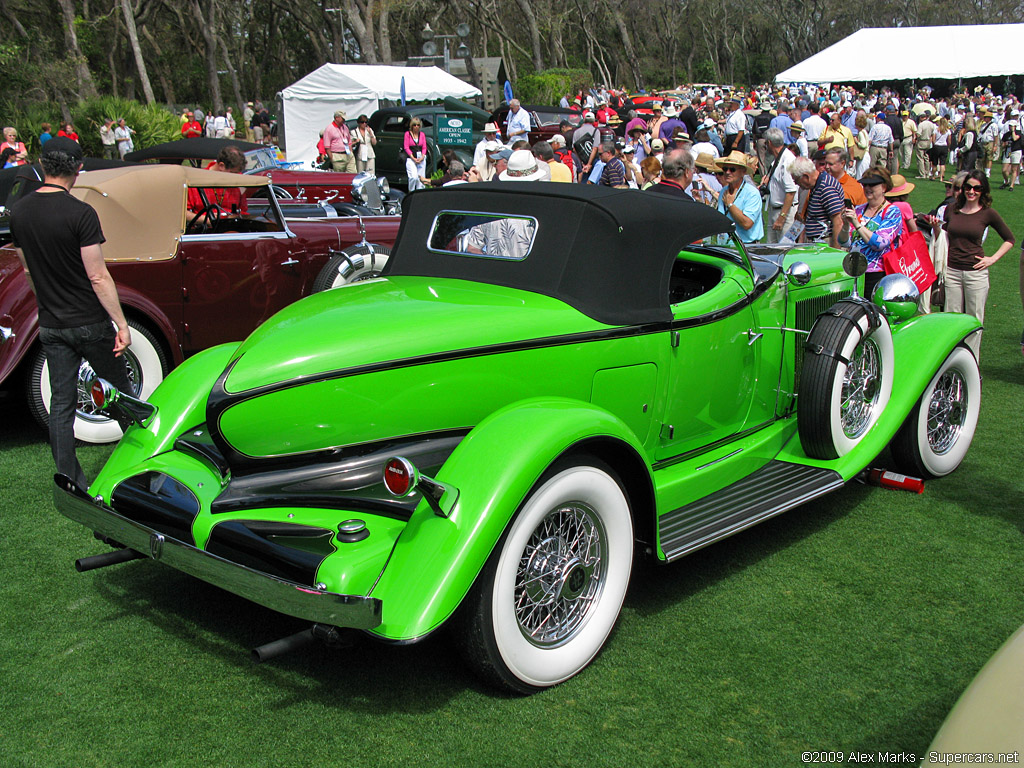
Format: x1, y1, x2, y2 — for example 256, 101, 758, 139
54, 182, 980, 692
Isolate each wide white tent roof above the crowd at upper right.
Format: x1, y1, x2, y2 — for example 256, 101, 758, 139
775, 24, 1024, 83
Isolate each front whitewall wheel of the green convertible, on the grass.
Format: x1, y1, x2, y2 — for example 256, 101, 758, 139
890, 346, 981, 477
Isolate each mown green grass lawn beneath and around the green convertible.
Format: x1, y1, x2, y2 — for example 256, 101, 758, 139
0, 163, 1024, 768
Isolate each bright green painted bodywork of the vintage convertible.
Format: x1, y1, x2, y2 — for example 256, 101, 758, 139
64, 183, 978, 659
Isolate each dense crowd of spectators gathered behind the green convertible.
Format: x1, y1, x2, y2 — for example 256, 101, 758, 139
423, 86, 1024, 354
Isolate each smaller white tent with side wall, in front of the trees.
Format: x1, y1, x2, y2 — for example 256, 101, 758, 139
281, 63, 480, 166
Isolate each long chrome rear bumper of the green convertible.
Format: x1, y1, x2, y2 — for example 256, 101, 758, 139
53, 475, 381, 630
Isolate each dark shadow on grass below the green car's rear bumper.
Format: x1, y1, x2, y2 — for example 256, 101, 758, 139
87, 561, 471, 713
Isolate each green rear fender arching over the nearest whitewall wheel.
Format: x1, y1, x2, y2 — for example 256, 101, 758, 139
371, 398, 650, 640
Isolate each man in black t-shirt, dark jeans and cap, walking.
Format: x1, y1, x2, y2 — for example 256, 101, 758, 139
10, 136, 133, 490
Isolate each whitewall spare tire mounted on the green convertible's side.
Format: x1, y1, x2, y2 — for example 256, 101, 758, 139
797, 299, 894, 459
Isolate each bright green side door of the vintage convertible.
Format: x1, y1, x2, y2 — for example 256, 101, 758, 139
655, 252, 761, 461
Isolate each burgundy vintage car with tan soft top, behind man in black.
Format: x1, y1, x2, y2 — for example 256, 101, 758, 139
0, 165, 399, 442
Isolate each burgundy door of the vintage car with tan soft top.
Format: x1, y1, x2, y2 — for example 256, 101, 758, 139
181, 191, 309, 353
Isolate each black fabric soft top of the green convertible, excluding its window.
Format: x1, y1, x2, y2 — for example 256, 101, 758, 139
384, 181, 733, 326
